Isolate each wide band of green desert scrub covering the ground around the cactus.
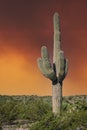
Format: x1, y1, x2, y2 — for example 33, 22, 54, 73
0, 95, 87, 130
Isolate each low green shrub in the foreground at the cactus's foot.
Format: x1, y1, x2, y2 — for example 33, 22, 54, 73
31, 111, 87, 130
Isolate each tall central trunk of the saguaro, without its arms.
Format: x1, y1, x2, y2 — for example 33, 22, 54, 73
52, 13, 62, 114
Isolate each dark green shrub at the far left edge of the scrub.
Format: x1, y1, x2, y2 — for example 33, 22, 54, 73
0, 100, 18, 123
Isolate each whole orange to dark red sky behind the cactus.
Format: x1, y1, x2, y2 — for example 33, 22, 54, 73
0, 0, 87, 95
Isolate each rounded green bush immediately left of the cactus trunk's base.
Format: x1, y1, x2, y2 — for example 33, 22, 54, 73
25, 99, 51, 121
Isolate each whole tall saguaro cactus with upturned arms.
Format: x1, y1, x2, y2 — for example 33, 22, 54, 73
37, 13, 68, 114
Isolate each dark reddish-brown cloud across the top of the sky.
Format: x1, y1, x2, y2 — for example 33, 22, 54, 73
0, 0, 87, 57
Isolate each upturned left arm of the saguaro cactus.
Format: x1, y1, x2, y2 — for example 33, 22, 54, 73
37, 46, 56, 81
